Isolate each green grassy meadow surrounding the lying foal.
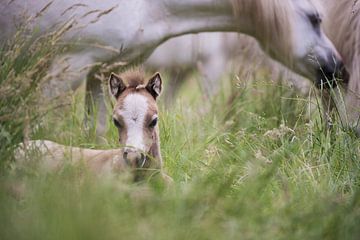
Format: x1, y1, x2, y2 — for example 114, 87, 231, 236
0, 26, 360, 240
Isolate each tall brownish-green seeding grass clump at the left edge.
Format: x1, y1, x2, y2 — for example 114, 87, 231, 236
0, 23, 65, 172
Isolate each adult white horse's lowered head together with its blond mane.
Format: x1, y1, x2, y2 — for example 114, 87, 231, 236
246, 0, 349, 86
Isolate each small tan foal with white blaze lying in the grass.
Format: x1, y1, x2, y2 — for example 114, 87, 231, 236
17, 72, 169, 180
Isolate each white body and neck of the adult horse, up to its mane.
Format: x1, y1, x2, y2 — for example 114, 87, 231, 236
0, 0, 251, 63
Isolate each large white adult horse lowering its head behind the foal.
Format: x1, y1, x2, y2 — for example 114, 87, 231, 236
0, 0, 346, 135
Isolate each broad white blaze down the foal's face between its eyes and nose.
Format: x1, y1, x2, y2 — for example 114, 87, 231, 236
119, 93, 148, 151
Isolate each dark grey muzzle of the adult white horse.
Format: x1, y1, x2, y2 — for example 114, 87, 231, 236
315, 57, 350, 88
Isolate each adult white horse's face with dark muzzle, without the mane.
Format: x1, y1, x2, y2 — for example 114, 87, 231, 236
292, 0, 349, 86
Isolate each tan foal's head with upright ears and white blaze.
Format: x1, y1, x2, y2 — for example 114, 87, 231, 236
109, 72, 162, 168
